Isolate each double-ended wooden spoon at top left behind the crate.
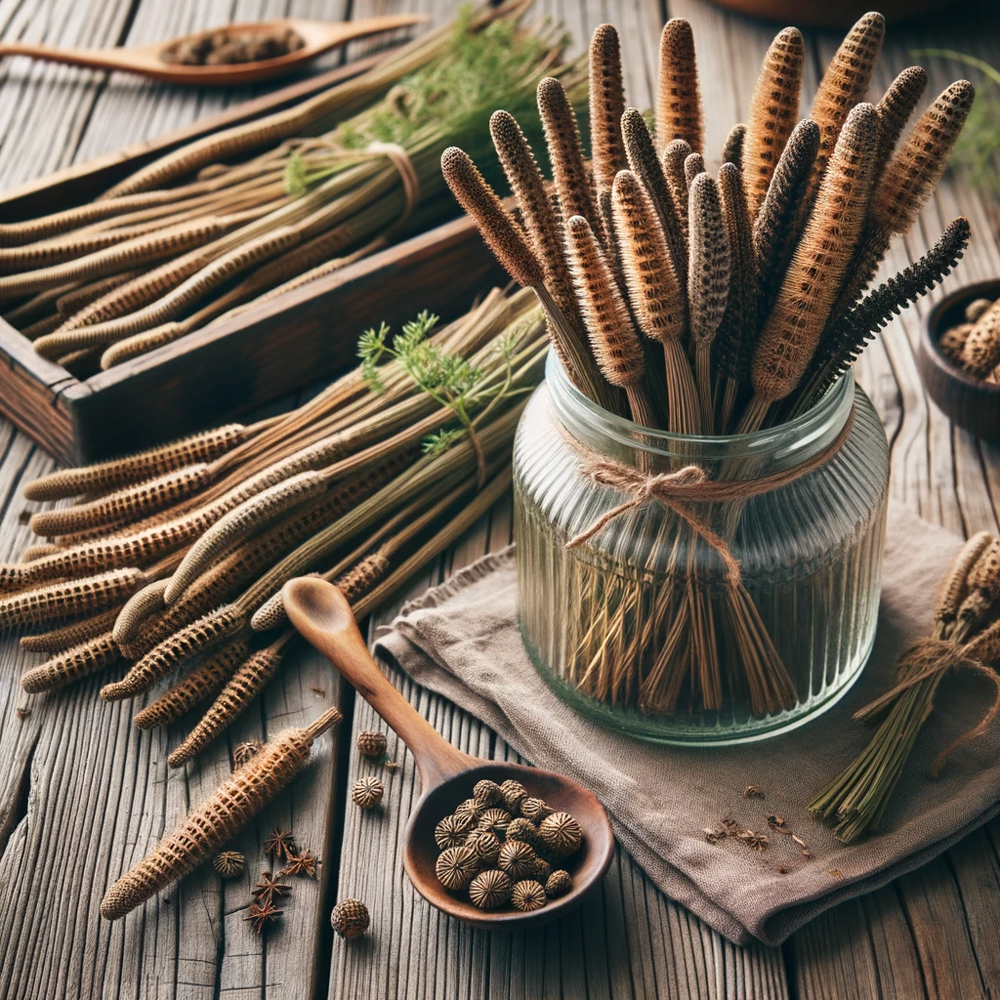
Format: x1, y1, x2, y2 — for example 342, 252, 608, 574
0, 14, 427, 85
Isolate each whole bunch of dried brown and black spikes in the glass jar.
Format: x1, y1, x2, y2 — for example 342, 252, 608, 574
442, 13, 974, 713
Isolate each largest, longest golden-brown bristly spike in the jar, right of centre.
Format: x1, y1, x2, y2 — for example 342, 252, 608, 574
742, 104, 878, 422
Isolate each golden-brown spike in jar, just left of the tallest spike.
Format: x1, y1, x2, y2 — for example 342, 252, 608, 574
741, 28, 805, 219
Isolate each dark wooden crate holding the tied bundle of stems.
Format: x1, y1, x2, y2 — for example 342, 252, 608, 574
0, 54, 504, 464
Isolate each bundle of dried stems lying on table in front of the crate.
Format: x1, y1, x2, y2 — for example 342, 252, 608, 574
0, 290, 548, 767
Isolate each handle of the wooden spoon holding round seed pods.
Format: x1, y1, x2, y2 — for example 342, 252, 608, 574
282, 576, 476, 792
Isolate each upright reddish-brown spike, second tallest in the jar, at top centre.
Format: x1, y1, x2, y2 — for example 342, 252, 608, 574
656, 17, 705, 152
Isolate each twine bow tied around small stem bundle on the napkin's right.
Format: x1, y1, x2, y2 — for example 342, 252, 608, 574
854, 638, 1000, 778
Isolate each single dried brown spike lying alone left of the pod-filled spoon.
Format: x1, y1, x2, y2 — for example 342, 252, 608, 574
101, 708, 341, 920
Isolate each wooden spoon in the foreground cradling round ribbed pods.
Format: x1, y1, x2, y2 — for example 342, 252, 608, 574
282, 577, 615, 929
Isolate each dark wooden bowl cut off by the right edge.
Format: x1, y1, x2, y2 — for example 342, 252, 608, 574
917, 278, 1000, 443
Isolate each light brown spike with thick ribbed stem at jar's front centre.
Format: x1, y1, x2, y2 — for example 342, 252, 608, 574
613, 169, 701, 434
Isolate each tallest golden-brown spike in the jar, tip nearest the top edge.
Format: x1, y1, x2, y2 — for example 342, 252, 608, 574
809, 12, 885, 190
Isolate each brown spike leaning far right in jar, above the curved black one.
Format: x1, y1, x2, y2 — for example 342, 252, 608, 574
869, 80, 976, 235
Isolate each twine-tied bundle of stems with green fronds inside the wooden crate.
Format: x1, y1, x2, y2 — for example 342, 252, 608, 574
0, 0, 581, 377
